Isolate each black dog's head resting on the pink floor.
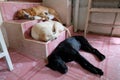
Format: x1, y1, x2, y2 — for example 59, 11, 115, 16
46, 58, 68, 74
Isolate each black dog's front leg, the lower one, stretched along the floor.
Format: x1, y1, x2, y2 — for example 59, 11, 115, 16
69, 49, 103, 75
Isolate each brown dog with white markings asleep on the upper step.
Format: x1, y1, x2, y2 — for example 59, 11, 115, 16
13, 5, 61, 22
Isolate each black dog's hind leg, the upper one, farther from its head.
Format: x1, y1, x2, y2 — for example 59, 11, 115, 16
77, 36, 105, 61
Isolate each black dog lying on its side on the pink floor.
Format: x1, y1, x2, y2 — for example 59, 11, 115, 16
46, 36, 105, 75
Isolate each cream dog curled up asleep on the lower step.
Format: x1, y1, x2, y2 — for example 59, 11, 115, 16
31, 20, 71, 42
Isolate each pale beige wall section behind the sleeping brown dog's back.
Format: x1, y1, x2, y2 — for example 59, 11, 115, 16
43, 0, 71, 25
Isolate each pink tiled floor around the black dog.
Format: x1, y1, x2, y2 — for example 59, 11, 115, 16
0, 34, 120, 80
